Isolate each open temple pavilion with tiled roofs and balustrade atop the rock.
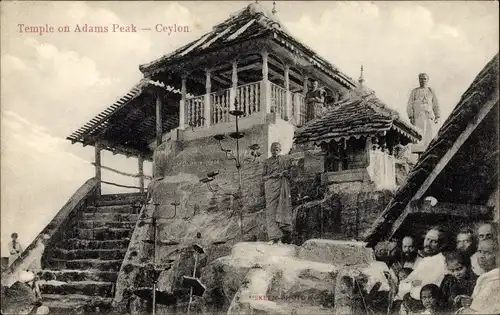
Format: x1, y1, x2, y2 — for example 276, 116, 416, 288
68, 3, 357, 199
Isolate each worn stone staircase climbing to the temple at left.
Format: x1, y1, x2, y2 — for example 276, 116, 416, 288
39, 194, 144, 314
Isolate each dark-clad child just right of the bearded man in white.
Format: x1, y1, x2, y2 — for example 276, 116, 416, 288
440, 251, 478, 312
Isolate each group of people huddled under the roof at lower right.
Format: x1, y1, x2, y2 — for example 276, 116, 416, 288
376, 223, 500, 314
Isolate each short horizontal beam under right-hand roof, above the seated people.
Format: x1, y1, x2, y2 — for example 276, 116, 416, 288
409, 199, 493, 218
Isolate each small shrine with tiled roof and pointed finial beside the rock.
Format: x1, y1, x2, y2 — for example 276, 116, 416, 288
294, 70, 421, 191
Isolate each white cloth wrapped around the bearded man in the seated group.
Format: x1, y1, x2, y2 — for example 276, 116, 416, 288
397, 253, 448, 300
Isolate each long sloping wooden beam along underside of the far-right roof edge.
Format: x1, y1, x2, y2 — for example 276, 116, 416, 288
389, 94, 498, 236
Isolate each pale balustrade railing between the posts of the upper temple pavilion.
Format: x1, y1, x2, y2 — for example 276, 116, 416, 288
184, 81, 306, 128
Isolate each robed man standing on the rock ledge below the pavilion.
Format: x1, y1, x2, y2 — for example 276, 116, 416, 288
262, 142, 292, 244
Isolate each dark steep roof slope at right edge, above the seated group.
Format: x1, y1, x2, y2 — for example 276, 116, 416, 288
365, 54, 499, 247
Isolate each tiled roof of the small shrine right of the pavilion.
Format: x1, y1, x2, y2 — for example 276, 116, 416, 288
294, 90, 422, 145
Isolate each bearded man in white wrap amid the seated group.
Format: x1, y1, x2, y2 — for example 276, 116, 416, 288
397, 227, 448, 312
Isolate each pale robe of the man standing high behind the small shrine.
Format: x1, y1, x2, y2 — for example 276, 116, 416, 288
407, 87, 439, 153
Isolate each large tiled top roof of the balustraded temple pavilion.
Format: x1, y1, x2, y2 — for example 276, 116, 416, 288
139, 3, 356, 88
